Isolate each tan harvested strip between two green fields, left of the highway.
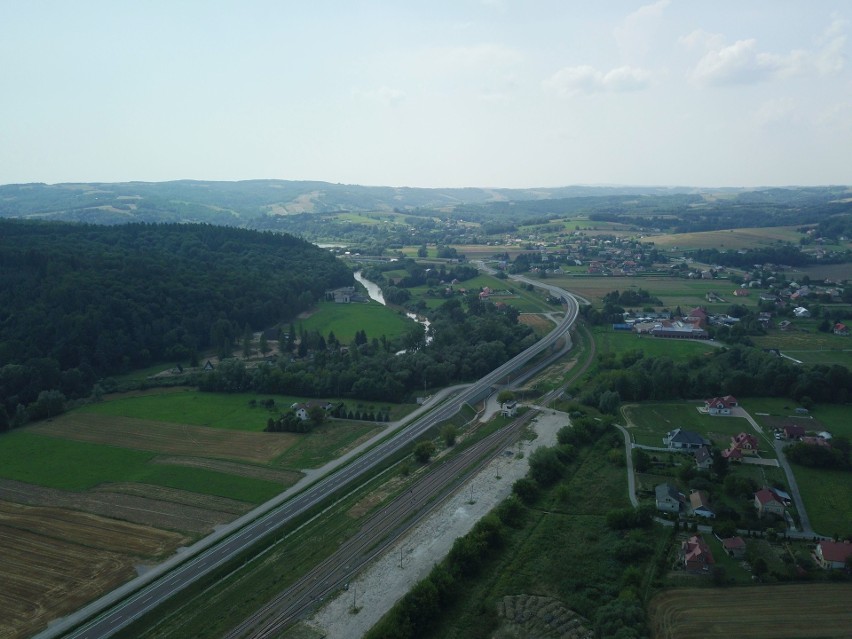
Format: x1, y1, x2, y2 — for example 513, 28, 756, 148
29, 412, 297, 464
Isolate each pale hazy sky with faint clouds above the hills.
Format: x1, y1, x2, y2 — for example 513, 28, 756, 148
0, 0, 852, 188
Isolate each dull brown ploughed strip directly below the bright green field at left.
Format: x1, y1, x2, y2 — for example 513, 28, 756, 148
0, 479, 243, 534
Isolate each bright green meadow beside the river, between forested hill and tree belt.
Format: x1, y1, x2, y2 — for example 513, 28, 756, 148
295, 302, 413, 344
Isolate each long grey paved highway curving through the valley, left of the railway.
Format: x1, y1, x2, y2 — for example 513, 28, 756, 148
45, 277, 579, 639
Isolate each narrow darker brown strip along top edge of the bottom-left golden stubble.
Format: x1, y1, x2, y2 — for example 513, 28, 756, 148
0, 501, 187, 558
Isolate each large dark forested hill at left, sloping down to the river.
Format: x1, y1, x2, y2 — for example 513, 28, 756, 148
0, 220, 352, 420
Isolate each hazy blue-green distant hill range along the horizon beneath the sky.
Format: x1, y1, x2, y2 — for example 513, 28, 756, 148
0, 180, 692, 226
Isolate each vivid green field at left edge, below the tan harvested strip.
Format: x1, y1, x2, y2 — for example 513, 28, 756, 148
0, 430, 281, 503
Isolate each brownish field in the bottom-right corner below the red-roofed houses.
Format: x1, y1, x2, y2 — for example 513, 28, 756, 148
650, 584, 852, 639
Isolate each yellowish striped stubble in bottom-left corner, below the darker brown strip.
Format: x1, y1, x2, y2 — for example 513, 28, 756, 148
0, 524, 131, 639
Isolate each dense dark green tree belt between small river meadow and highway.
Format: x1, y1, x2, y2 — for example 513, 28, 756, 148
199, 292, 536, 402
